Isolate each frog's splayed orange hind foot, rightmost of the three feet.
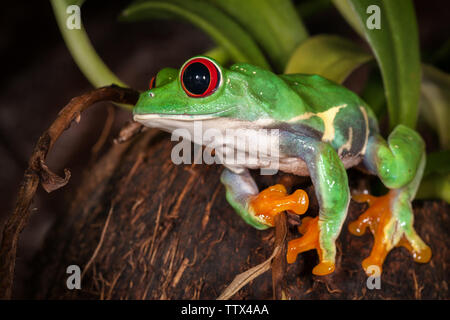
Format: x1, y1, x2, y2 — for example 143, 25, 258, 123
349, 190, 431, 275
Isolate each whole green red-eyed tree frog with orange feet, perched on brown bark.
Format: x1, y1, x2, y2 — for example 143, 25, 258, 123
133, 56, 431, 275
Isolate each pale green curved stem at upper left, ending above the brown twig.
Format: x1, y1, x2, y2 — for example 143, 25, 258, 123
51, 0, 126, 87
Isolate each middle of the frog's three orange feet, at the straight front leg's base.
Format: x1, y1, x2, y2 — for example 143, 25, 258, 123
286, 217, 334, 276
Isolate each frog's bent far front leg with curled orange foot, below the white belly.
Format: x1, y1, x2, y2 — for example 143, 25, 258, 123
220, 168, 308, 230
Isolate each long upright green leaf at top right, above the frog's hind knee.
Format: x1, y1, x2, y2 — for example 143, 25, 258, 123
334, 0, 421, 129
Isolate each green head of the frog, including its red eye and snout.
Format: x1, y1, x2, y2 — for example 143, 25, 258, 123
133, 56, 302, 131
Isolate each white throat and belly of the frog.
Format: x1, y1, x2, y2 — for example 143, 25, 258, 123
134, 115, 361, 176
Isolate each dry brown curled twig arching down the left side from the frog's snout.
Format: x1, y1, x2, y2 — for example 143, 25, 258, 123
0, 86, 138, 299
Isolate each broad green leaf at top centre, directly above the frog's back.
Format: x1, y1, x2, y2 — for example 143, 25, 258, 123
209, 0, 308, 72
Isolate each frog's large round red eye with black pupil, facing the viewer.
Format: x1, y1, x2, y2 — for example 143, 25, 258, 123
180, 58, 221, 98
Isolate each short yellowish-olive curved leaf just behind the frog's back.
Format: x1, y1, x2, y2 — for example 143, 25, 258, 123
285, 35, 373, 83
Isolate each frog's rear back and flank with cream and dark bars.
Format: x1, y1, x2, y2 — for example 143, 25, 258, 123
280, 74, 378, 157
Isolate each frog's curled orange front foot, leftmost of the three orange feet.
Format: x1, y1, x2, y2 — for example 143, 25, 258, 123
250, 184, 309, 226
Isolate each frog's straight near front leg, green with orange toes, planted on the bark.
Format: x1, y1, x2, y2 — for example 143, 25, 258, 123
282, 134, 350, 275
